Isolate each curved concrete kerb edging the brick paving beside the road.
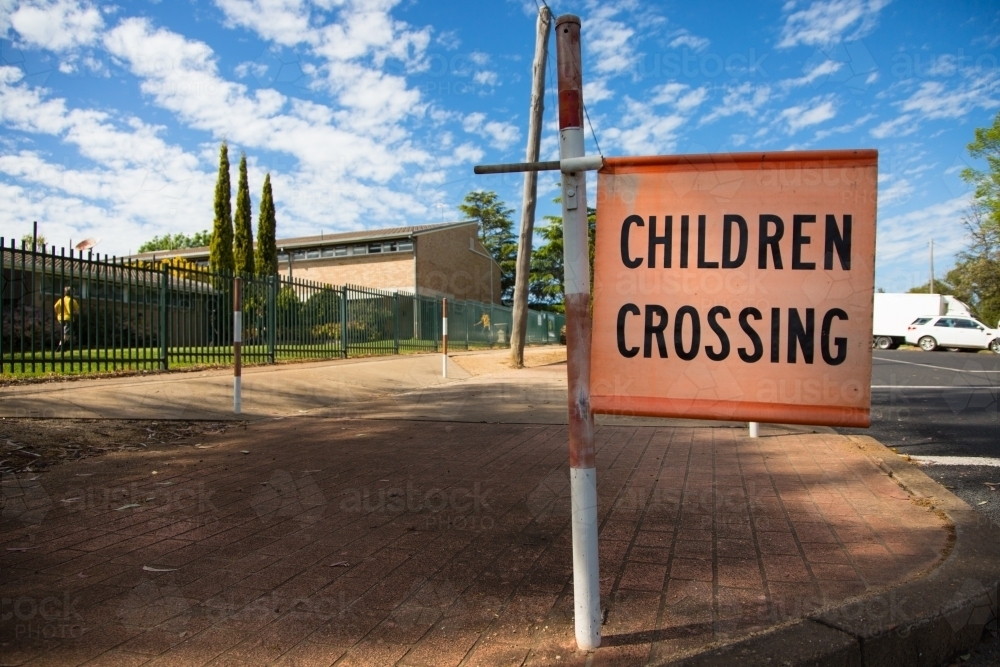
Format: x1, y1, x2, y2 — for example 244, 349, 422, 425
660, 436, 1000, 667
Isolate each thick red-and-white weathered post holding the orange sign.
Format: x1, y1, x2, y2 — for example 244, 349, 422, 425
556, 14, 601, 650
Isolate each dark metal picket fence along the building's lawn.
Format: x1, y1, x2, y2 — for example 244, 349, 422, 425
0, 238, 565, 375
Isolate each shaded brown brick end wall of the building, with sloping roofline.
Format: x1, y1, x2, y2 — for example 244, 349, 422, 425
414, 225, 500, 303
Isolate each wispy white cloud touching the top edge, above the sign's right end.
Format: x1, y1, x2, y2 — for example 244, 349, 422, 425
778, 0, 890, 48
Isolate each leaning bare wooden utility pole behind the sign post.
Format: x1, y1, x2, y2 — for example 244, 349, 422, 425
510, 5, 552, 368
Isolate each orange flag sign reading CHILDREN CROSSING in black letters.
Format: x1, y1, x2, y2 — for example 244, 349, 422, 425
591, 150, 878, 426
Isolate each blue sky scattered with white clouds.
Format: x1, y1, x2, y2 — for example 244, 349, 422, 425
0, 0, 1000, 291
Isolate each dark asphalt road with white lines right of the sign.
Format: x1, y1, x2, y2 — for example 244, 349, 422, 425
837, 350, 1000, 525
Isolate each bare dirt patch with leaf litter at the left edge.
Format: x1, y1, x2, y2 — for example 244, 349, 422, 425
0, 419, 246, 473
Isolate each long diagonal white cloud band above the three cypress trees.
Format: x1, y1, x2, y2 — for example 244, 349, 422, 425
105, 18, 427, 183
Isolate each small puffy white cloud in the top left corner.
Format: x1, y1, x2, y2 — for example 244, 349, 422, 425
9, 0, 104, 52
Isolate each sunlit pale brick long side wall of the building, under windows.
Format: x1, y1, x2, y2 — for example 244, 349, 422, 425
278, 252, 414, 292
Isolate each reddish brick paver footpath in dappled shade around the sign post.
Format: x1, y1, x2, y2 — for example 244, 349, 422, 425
0, 417, 954, 665
